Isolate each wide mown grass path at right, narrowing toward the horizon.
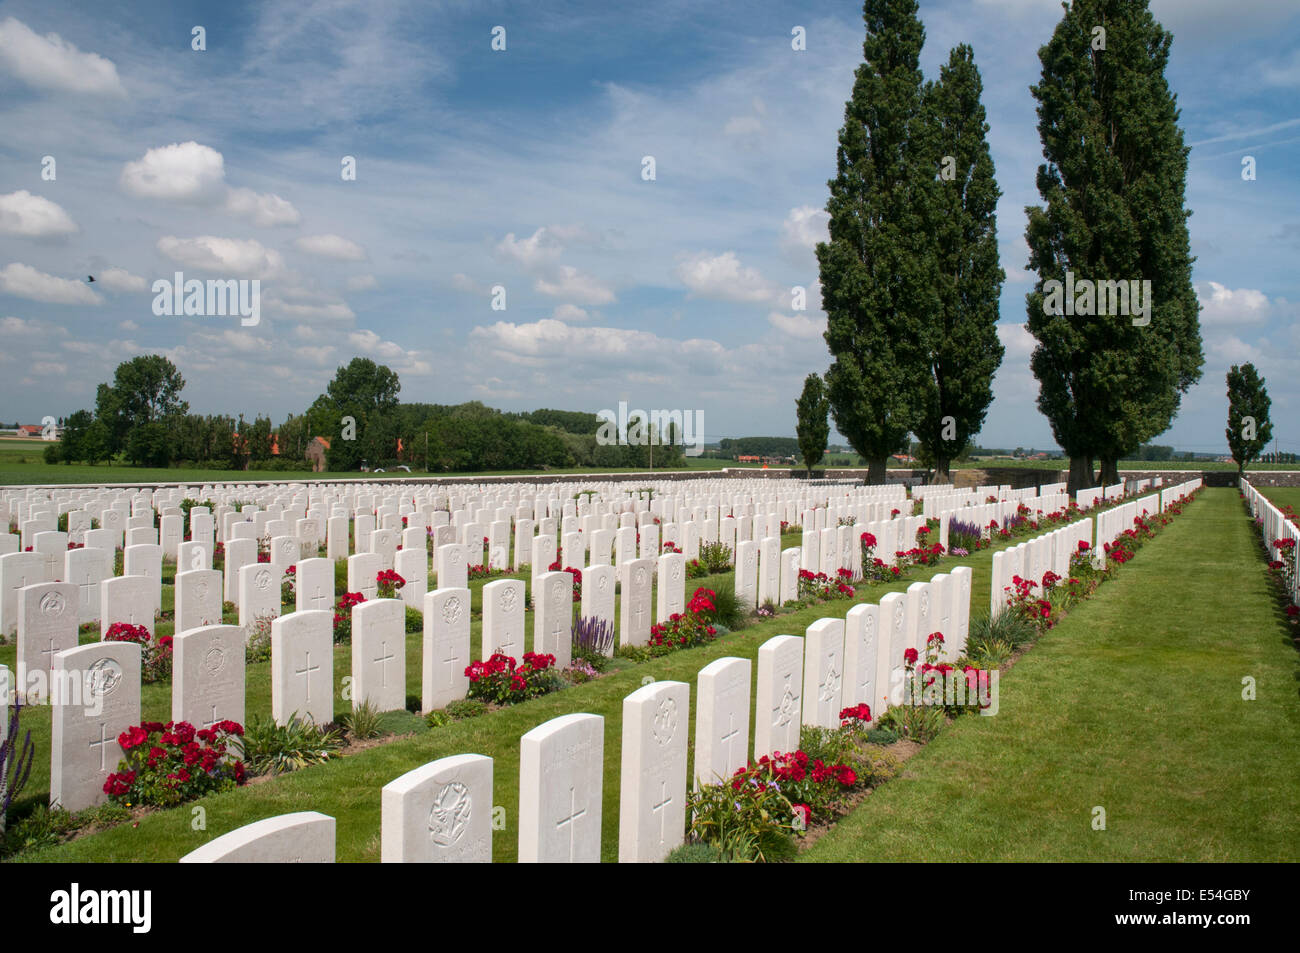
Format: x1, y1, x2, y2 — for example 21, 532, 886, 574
801, 489, 1300, 862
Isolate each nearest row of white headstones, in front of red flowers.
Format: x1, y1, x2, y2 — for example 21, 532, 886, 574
182, 567, 970, 863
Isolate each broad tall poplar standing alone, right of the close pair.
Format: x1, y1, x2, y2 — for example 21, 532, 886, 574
1026, 0, 1204, 491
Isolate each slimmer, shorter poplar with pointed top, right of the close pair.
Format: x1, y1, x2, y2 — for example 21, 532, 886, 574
913, 44, 1005, 482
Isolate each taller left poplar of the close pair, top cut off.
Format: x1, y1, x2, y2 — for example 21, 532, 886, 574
816, 0, 939, 484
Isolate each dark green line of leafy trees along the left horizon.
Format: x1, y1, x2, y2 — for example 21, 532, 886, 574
46, 354, 702, 472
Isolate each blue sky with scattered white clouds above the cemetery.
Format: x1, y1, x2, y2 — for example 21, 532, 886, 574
0, 0, 1300, 451
